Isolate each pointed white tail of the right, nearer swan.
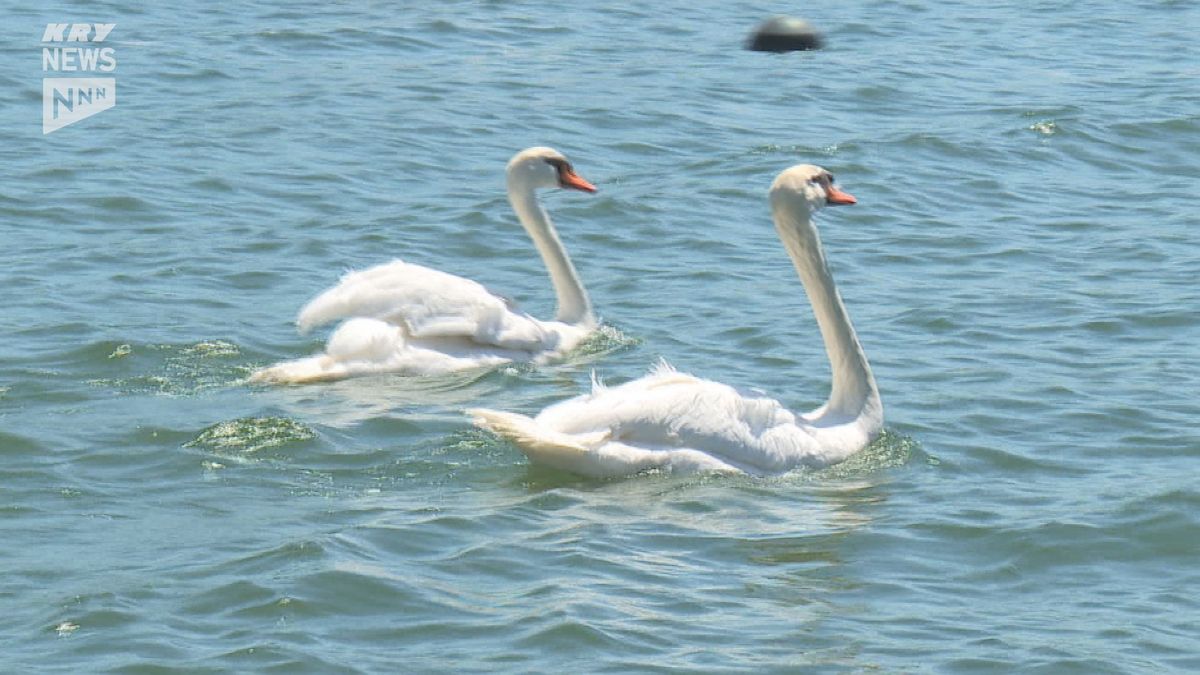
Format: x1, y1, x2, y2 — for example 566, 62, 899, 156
467, 408, 612, 473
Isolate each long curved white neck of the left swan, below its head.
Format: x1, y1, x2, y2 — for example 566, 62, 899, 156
509, 178, 595, 324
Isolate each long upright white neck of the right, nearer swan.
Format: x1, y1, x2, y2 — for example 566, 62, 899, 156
774, 203, 883, 424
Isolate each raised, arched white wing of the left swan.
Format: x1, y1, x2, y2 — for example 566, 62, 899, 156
296, 261, 553, 350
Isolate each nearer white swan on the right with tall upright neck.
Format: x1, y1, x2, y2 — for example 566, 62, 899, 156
467, 165, 883, 478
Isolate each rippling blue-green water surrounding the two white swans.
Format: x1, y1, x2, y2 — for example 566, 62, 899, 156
0, 0, 1200, 674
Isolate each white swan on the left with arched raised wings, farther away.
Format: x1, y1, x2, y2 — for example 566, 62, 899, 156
250, 147, 596, 383
